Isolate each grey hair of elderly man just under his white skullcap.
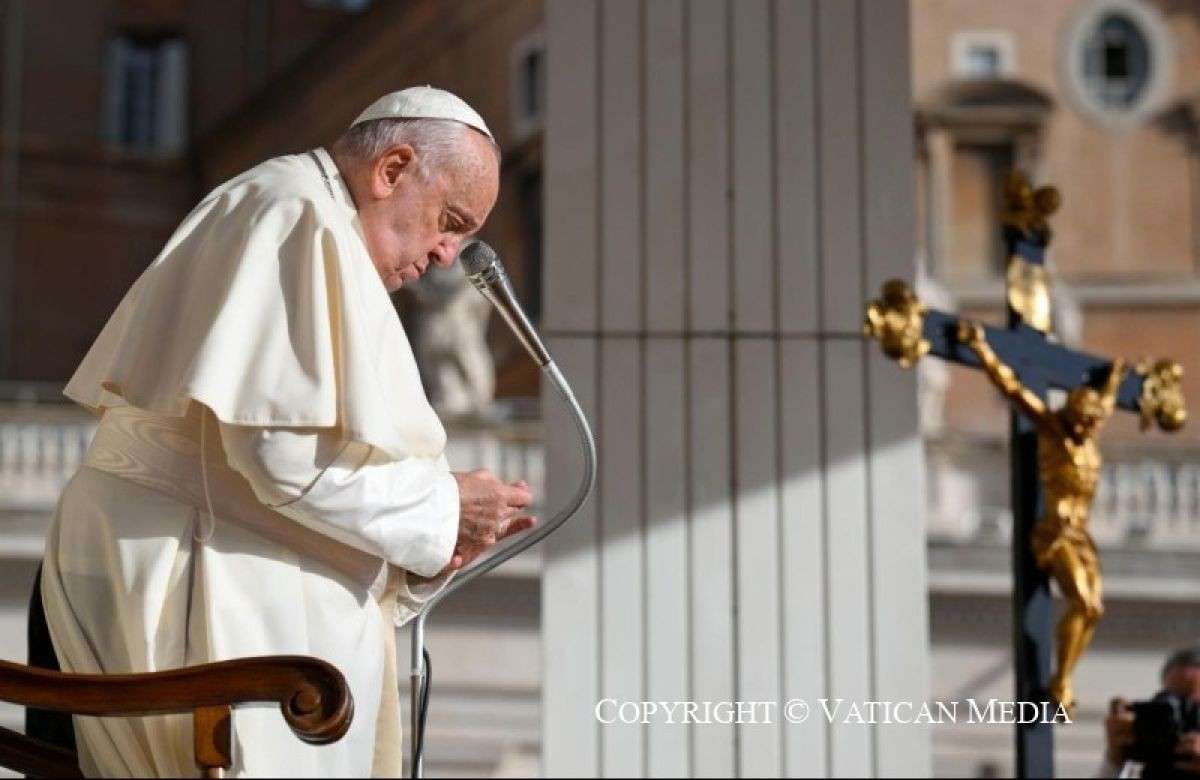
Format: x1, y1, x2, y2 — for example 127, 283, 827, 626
332, 119, 500, 176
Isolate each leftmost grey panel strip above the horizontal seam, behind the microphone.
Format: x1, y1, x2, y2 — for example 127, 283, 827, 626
542, 0, 599, 331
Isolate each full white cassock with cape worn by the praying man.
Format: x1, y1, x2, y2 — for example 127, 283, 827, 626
42, 149, 458, 776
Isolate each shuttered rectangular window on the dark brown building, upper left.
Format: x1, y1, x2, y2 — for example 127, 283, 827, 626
101, 35, 187, 156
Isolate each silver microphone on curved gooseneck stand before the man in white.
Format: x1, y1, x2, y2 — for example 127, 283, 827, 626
410, 241, 596, 778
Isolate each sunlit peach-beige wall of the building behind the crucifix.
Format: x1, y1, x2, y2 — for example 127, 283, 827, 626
912, 0, 1200, 445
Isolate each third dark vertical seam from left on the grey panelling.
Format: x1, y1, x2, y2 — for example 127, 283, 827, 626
679, 0, 696, 776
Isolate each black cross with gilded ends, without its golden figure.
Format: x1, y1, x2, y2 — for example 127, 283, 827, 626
865, 181, 1184, 778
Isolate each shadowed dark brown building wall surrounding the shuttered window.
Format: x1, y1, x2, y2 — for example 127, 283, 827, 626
0, 0, 347, 383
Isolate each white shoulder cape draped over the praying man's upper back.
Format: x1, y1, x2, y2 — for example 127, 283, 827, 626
65, 149, 445, 460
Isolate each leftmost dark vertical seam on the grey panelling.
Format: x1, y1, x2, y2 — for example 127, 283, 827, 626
592, 2, 605, 778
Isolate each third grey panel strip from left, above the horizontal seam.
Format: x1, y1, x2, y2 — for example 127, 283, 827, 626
644, 0, 686, 332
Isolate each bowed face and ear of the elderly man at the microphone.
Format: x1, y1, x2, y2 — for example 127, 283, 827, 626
359, 132, 500, 293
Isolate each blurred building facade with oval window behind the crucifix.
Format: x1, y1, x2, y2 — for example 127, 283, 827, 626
912, 0, 1200, 776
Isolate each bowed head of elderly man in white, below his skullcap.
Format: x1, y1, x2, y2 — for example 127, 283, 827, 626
331, 111, 500, 292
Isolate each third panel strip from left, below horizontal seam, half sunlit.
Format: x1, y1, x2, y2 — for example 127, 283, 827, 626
646, 338, 691, 778
